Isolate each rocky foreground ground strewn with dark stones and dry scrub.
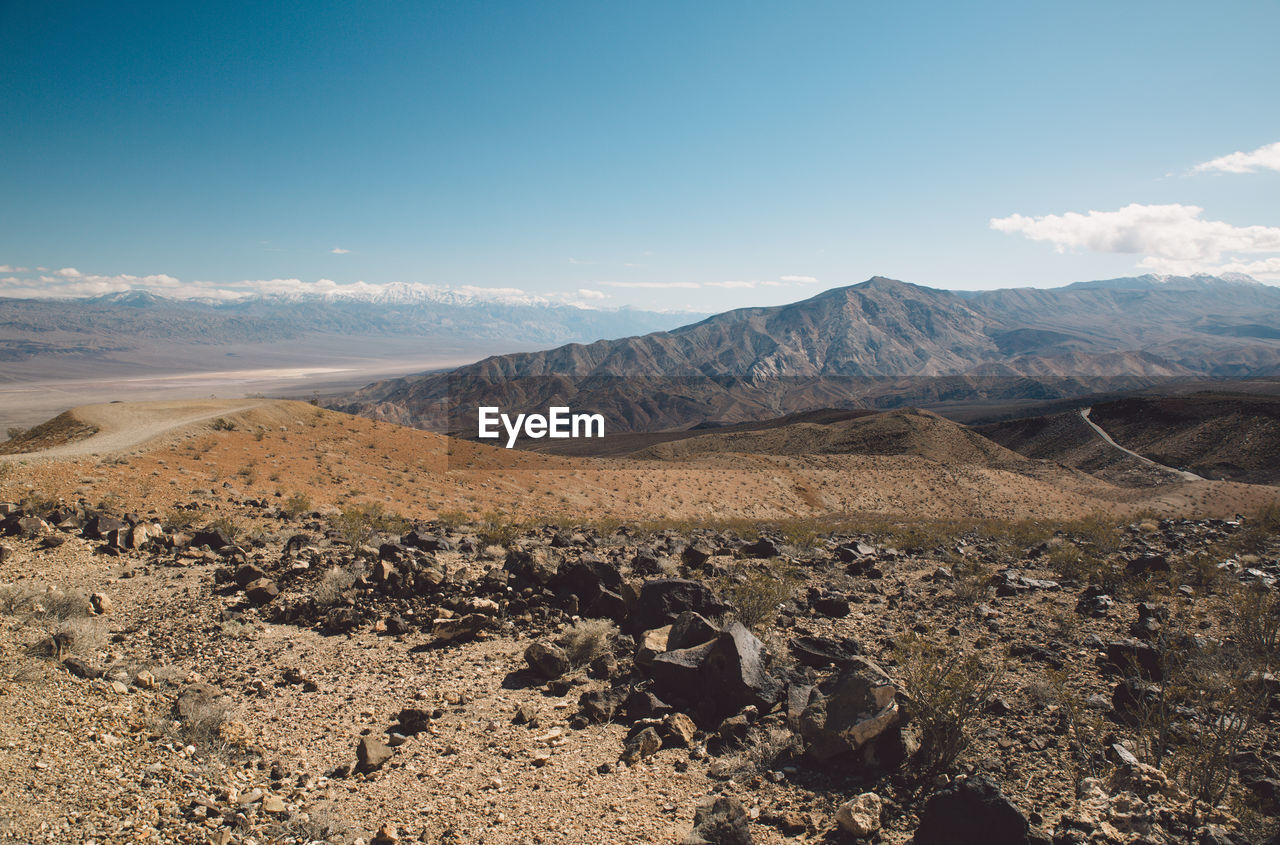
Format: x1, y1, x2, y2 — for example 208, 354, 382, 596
0, 489, 1280, 845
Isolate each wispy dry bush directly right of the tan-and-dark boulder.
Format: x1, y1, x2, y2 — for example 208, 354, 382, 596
895, 636, 1005, 778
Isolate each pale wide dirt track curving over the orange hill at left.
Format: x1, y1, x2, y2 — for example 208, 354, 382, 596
0, 399, 271, 460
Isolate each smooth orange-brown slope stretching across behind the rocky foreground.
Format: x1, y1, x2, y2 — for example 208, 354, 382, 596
0, 401, 1277, 521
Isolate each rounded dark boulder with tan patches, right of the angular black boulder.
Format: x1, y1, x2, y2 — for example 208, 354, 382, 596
800, 657, 901, 761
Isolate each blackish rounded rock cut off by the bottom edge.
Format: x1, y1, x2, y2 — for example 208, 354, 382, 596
914, 775, 1042, 845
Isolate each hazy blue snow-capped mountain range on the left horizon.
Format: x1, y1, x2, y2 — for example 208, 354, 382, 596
0, 290, 689, 364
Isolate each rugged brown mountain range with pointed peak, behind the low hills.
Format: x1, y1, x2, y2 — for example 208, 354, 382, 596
332, 275, 1280, 433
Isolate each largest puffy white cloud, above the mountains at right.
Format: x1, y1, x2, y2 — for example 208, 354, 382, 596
991, 204, 1280, 278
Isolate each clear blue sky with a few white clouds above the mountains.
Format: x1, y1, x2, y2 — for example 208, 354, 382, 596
0, 0, 1280, 310
